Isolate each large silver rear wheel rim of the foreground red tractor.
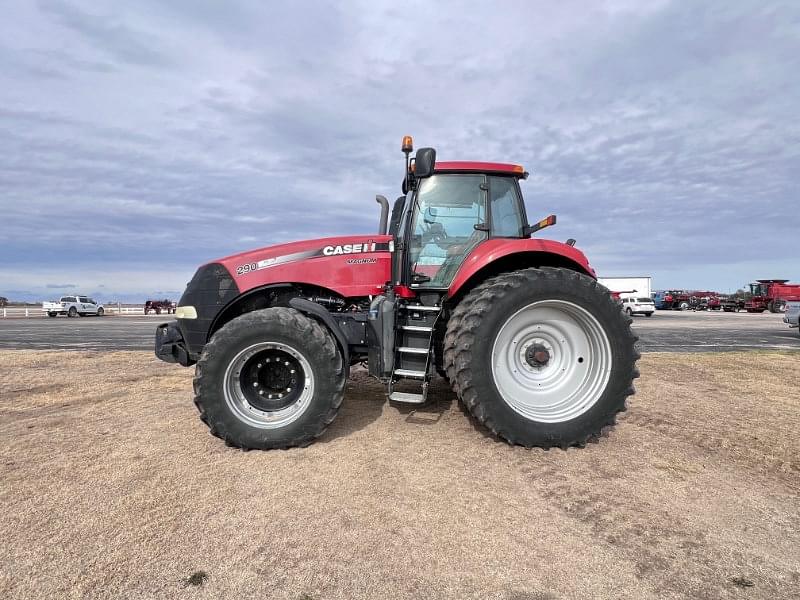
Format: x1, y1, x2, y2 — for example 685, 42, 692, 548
492, 300, 612, 423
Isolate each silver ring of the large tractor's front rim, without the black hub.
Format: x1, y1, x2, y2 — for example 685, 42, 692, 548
224, 342, 314, 429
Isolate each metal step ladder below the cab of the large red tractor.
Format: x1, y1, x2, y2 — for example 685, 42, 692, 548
389, 304, 442, 404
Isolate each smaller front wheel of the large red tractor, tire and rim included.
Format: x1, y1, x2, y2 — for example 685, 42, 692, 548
194, 307, 345, 450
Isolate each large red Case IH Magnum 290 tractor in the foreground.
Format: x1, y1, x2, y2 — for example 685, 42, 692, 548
155, 136, 639, 449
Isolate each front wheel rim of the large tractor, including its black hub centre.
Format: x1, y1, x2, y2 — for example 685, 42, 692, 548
224, 342, 314, 429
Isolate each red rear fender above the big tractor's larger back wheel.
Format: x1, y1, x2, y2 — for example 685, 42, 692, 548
447, 238, 597, 298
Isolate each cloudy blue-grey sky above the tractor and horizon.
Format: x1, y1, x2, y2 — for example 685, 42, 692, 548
0, 0, 800, 301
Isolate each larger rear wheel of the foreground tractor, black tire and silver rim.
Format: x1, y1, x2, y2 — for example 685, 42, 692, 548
445, 267, 639, 448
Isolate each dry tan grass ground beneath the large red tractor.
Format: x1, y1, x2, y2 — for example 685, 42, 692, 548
0, 351, 800, 600
